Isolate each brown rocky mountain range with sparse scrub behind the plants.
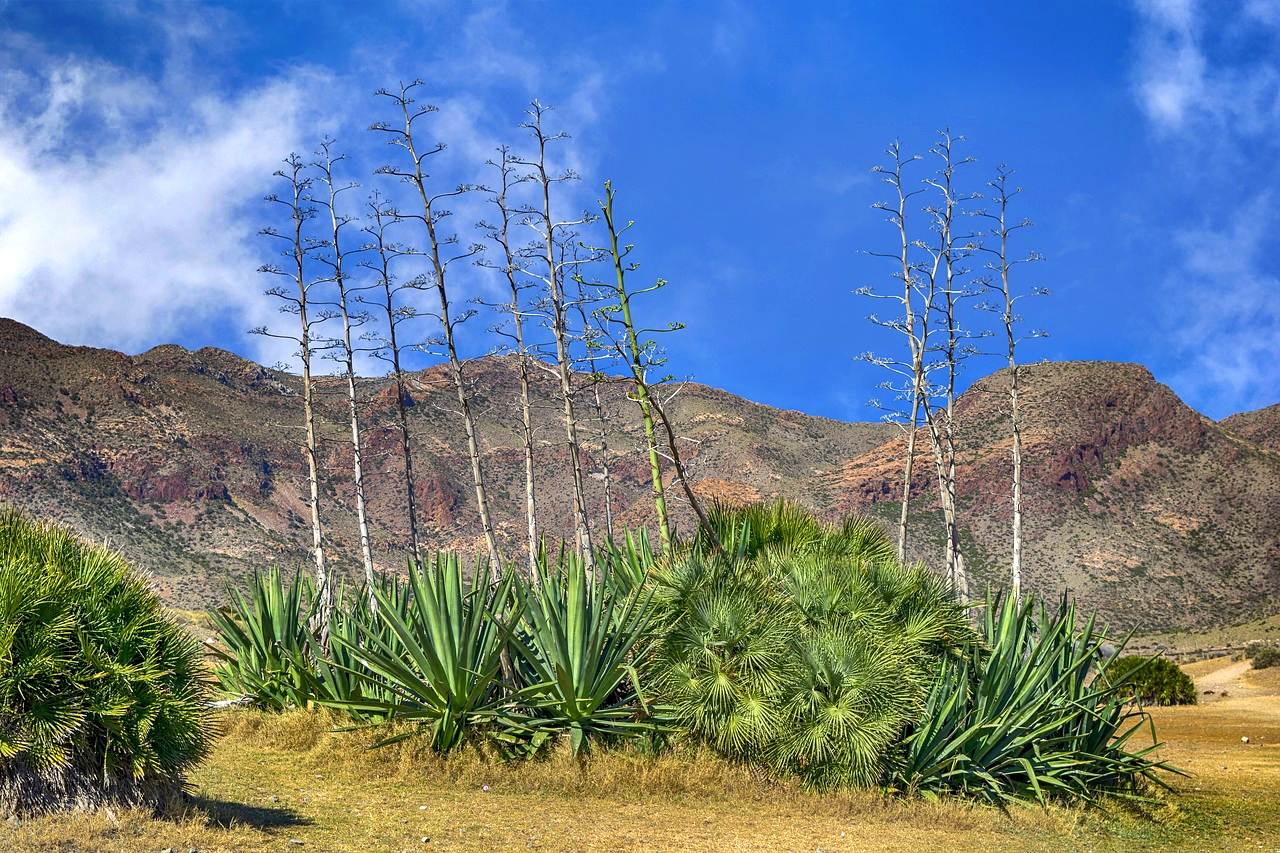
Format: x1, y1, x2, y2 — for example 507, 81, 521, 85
0, 320, 1280, 628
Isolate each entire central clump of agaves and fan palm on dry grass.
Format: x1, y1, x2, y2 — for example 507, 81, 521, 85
214, 503, 1170, 804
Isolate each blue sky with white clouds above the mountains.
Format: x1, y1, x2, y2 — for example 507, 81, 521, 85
0, 0, 1280, 419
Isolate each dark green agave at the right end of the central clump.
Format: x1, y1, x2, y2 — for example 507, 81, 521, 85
890, 598, 1178, 804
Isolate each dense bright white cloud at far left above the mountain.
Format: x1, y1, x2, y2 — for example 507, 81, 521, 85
0, 34, 335, 357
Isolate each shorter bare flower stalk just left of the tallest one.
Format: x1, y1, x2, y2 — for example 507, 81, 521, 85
361, 191, 422, 564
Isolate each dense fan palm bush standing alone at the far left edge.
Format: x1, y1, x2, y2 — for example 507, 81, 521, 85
0, 510, 211, 813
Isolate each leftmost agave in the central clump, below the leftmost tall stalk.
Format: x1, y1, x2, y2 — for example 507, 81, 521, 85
209, 566, 315, 711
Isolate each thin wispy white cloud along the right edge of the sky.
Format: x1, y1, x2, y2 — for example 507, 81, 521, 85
1133, 0, 1280, 418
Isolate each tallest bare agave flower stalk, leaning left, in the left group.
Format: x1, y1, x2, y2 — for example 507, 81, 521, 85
371, 81, 502, 566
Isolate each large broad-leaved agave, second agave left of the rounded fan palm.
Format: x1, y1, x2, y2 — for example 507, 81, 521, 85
317, 553, 515, 752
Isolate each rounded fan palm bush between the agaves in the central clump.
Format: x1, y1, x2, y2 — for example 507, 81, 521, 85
649, 503, 972, 788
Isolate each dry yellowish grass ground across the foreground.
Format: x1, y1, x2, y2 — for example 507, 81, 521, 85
0, 660, 1280, 853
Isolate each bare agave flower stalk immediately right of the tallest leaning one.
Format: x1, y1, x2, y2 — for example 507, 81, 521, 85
476, 146, 539, 580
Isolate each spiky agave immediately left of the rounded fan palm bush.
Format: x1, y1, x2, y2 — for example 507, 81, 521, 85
495, 551, 654, 754
